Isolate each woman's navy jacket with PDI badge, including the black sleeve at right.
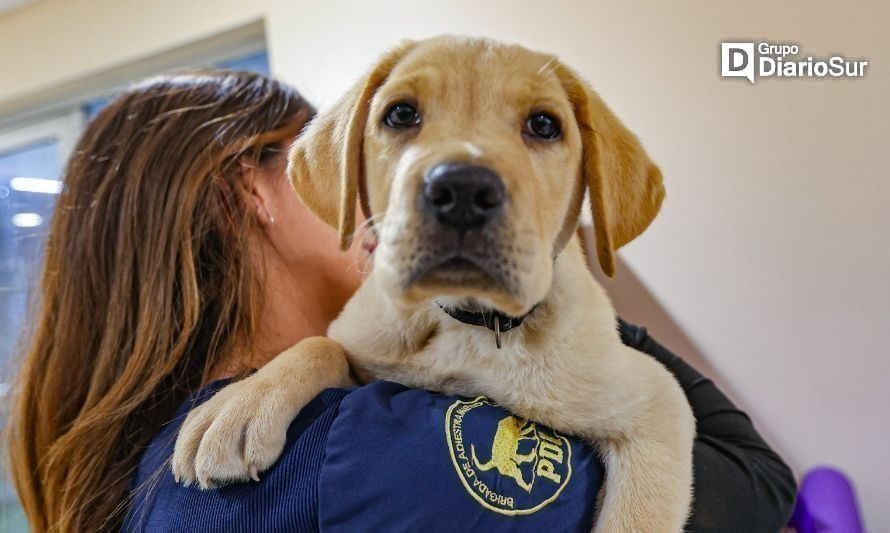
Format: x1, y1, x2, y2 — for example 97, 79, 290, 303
123, 323, 795, 533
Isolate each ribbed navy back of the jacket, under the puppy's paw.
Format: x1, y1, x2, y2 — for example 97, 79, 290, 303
123, 382, 351, 533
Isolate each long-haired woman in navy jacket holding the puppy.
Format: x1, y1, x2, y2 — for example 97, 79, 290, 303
10, 71, 794, 531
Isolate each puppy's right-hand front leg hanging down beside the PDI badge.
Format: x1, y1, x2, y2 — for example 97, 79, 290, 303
594, 347, 695, 533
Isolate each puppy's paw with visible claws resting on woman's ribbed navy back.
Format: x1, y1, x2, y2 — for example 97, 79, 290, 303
172, 376, 304, 489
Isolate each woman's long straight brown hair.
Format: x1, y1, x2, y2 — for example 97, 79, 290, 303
9, 71, 313, 532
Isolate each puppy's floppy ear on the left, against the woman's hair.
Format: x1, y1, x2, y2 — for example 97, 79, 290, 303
288, 41, 415, 250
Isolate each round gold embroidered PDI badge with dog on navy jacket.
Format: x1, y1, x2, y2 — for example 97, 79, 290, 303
445, 397, 572, 515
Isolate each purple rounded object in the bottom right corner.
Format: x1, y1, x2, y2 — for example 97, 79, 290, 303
788, 467, 864, 533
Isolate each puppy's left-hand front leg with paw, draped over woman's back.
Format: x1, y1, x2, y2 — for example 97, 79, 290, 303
172, 337, 352, 489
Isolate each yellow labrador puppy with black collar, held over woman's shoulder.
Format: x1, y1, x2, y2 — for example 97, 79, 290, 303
173, 37, 695, 533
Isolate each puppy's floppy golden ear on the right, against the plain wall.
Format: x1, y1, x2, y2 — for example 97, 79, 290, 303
555, 64, 664, 276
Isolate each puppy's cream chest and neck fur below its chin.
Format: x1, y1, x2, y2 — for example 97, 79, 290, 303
329, 242, 620, 424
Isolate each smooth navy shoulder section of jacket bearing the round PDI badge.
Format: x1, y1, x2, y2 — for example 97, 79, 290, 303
319, 382, 603, 531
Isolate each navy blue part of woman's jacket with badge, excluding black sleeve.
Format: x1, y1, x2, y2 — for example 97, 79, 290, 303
126, 382, 602, 532
